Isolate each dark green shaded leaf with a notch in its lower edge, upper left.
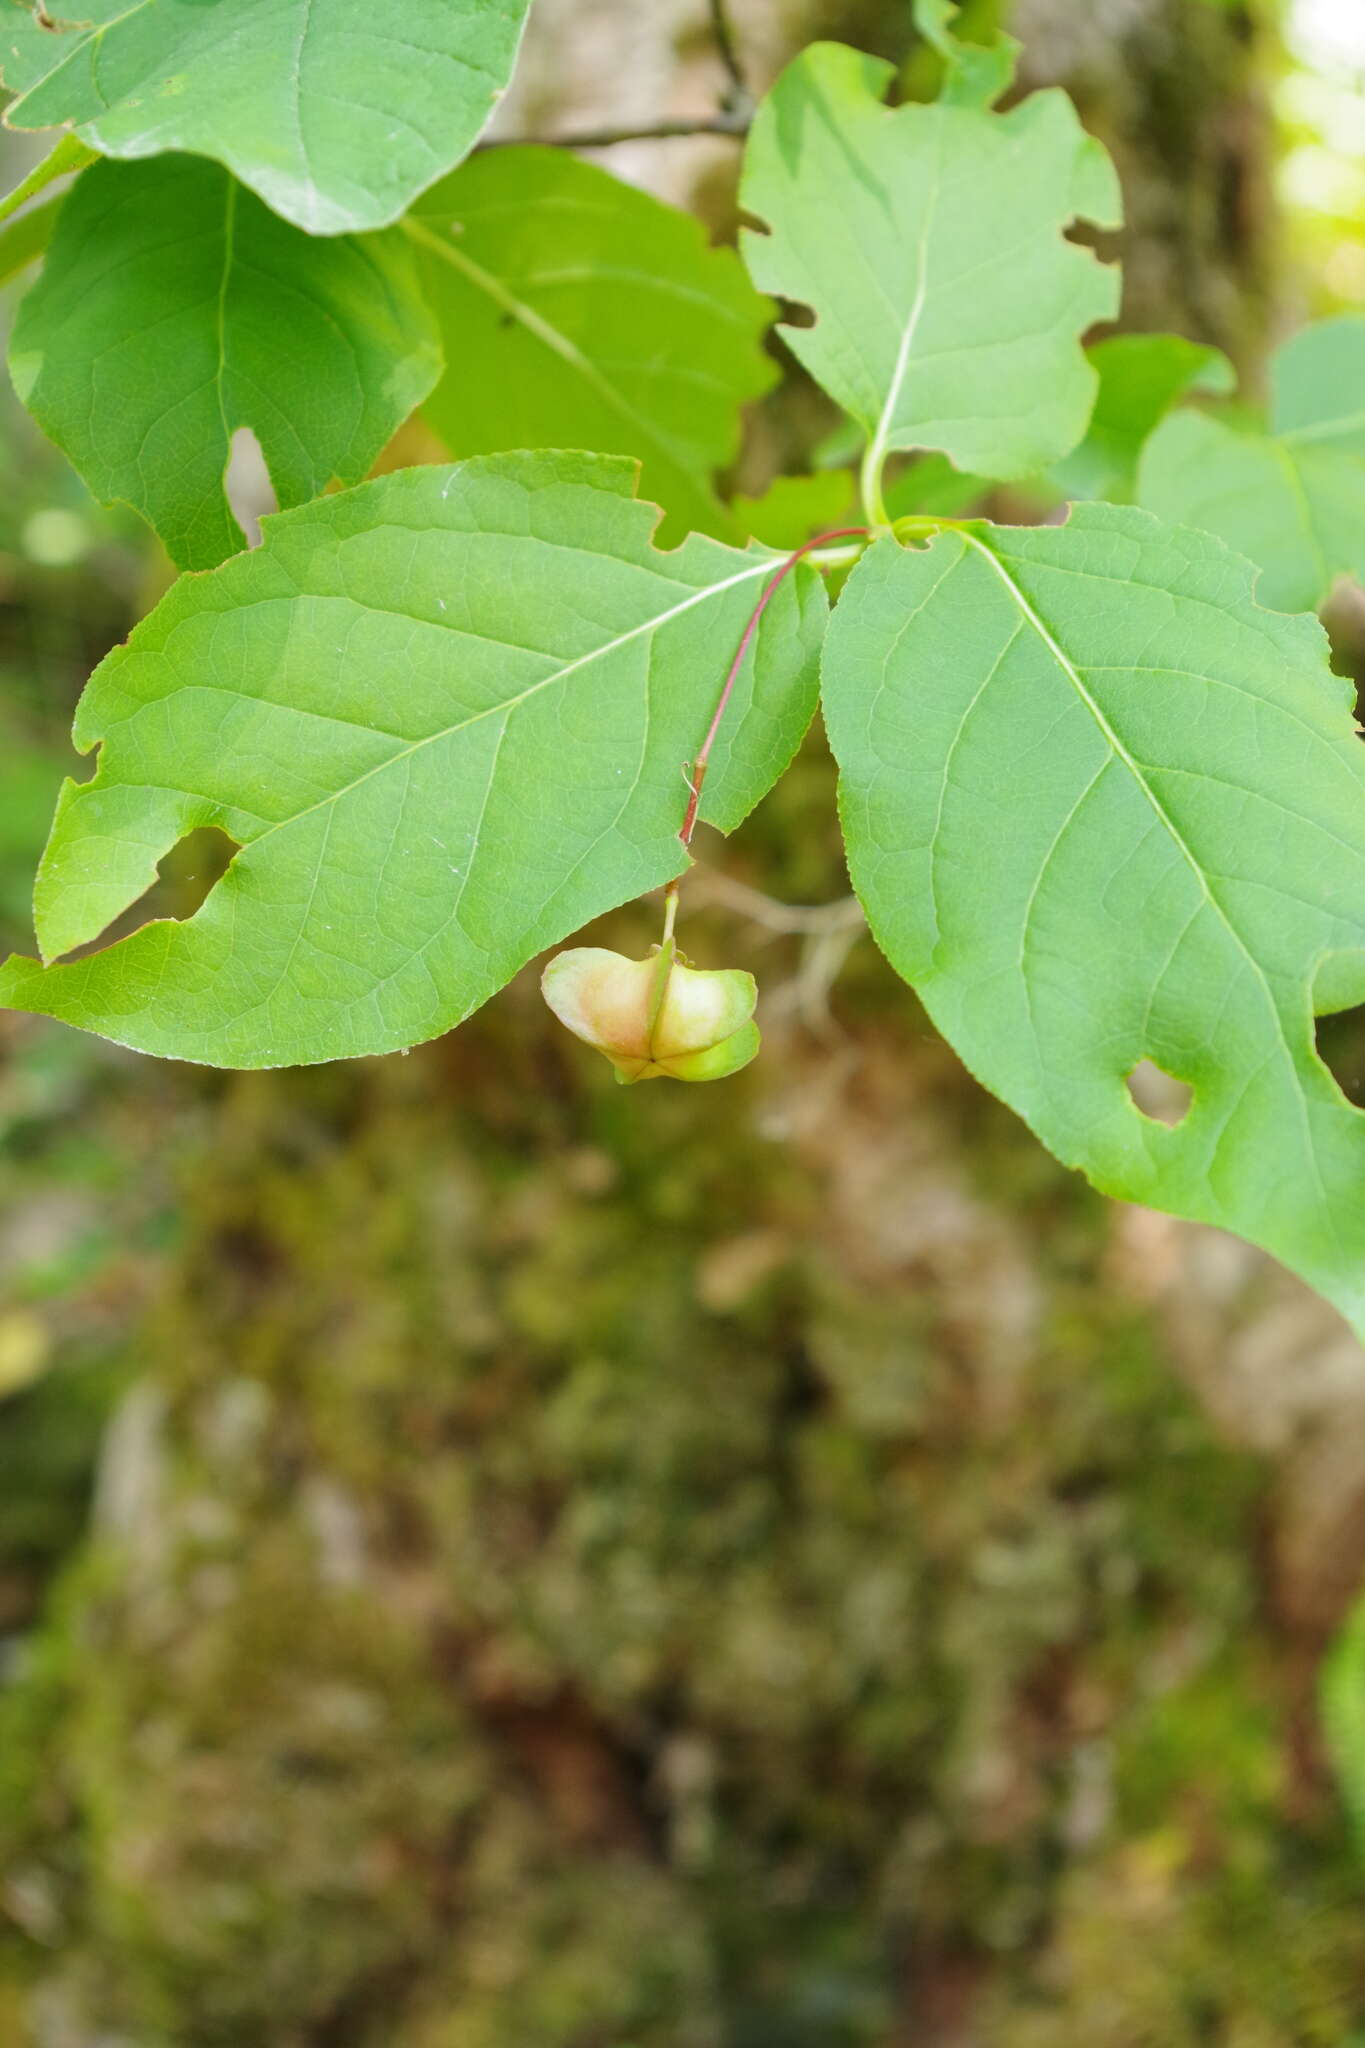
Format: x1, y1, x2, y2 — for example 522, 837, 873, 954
10, 156, 440, 569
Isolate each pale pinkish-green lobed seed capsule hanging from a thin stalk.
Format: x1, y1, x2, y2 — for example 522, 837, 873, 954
540, 938, 759, 1083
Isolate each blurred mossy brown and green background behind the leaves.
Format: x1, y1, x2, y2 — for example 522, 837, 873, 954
0, 0, 1365, 2048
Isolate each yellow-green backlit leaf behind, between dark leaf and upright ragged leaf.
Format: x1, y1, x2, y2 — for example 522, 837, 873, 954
407, 150, 776, 537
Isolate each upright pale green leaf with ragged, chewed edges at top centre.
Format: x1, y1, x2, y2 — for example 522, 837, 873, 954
741, 43, 1119, 505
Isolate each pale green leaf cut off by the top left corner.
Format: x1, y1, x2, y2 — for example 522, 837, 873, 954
0, 0, 530, 236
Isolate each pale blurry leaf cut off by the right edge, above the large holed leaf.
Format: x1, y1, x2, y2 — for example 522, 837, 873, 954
1138, 313, 1365, 612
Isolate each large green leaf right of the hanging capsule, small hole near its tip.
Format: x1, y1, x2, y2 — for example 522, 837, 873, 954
823, 506, 1365, 1333
